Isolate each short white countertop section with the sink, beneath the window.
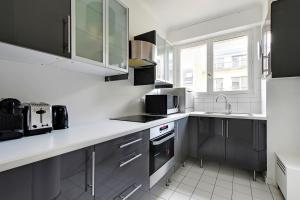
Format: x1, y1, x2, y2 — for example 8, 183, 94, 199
189, 112, 267, 120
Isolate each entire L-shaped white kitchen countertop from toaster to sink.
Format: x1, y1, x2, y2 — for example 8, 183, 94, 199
0, 112, 266, 172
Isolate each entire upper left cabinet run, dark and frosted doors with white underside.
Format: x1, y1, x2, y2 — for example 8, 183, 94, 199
0, 0, 129, 75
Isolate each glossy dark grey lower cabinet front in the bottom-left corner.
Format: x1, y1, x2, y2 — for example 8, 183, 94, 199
0, 157, 60, 200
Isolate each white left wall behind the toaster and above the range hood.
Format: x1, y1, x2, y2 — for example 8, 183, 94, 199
0, 0, 166, 125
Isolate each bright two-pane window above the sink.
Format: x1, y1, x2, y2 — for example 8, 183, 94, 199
179, 32, 251, 92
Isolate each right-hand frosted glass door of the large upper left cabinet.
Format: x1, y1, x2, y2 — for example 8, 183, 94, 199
107, 0, 128, 71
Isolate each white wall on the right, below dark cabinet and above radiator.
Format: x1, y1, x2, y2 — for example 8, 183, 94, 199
267, 77, 300, 184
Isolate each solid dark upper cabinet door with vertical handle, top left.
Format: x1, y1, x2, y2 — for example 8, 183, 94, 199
0, 0, 71, 58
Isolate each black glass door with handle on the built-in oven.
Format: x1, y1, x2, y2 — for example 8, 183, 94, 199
150, 130, 175, 176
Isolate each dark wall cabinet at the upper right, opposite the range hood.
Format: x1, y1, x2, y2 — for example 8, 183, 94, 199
271, 0, 300, 78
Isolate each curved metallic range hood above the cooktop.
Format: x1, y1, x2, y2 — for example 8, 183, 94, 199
129, 40, 156, 68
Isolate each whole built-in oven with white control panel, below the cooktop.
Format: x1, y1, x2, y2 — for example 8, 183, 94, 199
149, 122, 175, 187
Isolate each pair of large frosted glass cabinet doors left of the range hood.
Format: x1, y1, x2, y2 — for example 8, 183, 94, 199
72, 0, 128, 72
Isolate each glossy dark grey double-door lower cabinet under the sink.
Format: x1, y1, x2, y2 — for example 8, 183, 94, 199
198, 118, 266, 171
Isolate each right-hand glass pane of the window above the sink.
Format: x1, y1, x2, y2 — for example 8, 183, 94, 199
213, 36, 248, 92
